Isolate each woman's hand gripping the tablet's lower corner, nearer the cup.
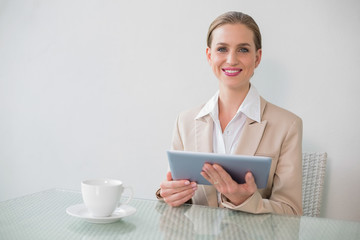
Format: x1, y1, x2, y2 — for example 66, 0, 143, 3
160, 172, 197, 207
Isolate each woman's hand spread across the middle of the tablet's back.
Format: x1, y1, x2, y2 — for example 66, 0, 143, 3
201, 163, 257, 205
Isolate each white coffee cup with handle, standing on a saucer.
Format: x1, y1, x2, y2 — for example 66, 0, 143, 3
81, 179, 133, 217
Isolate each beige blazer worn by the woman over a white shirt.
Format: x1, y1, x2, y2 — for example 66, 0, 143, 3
172, 98, 302, 215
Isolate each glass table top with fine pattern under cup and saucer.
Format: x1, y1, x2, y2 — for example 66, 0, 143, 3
0, 189, 360, 240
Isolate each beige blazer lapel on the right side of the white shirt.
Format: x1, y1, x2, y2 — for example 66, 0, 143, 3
235, 98, 267, 155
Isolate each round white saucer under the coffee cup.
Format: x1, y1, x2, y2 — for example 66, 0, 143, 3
66, 204, 136, 223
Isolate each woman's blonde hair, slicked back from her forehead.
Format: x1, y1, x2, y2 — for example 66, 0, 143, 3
207, 12, 261, 50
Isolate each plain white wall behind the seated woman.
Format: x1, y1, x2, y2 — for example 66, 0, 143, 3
0, 0, 360, 221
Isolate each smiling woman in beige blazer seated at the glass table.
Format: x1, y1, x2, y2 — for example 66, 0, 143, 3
157, 12, 302, 215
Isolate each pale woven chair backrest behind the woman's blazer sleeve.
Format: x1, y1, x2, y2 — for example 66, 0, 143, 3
302, 153, 327, 217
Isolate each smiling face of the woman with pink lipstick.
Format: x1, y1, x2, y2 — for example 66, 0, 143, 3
206, 23, 261, 90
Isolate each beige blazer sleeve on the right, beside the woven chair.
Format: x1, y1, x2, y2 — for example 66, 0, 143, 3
221, 118, 302, 215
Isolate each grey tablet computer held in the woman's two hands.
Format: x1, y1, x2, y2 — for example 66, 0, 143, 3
167, 151, 271, 189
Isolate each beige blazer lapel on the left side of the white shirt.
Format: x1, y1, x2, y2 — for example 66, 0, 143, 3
195, 115, 214, 152
